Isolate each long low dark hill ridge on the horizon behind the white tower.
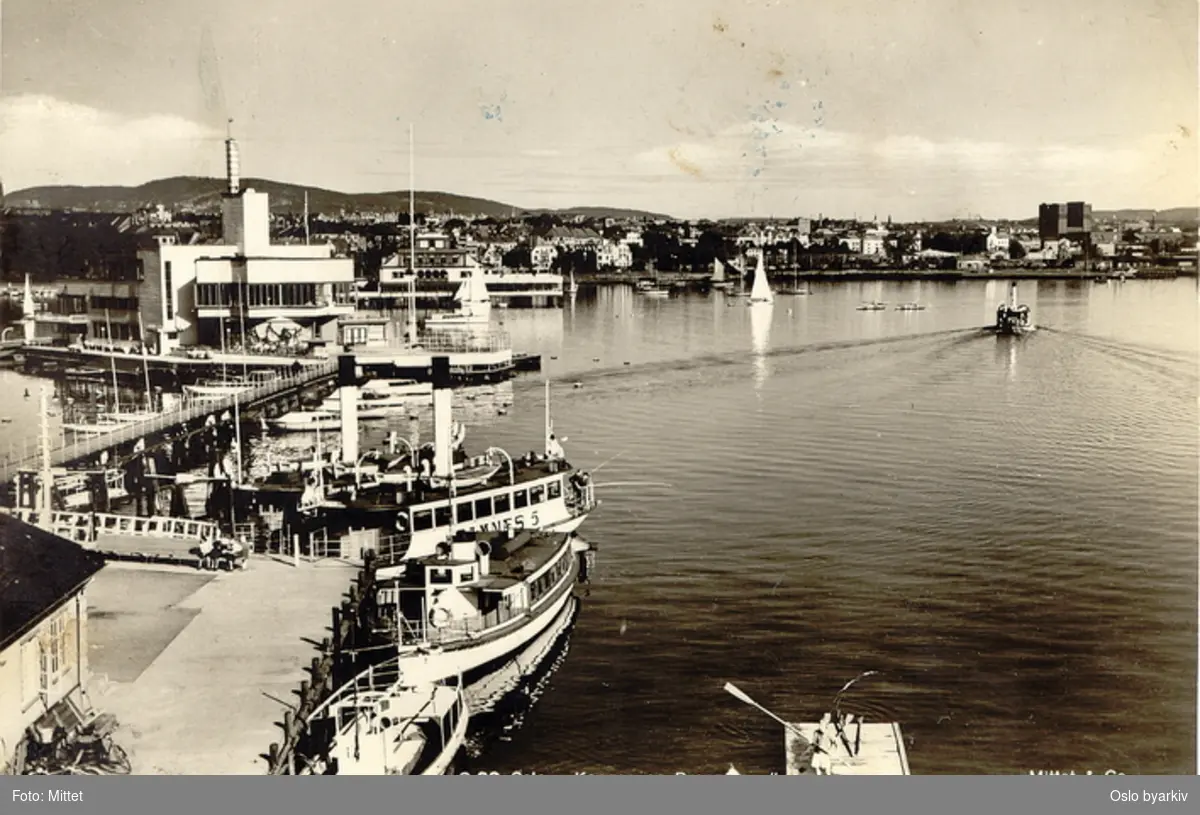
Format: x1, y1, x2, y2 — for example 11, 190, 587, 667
4, 175, 664, 217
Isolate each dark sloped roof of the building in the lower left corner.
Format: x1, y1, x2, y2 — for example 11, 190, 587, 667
0, 515, 104, 651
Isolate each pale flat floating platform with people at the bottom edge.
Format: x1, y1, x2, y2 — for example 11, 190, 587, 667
784, 721, 912, 775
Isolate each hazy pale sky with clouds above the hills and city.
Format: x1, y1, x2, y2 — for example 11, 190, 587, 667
0, 0, 1198, 221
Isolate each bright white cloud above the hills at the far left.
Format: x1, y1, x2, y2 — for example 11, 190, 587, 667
0, 95, 222, 191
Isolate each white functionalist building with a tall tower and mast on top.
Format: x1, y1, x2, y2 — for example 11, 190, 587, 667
138, 138, 354, 354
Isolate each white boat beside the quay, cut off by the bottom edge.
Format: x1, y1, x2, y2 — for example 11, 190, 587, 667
298, 659, 470, 775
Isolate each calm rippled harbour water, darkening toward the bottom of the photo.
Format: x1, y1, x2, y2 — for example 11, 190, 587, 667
0, 280, 1200, 774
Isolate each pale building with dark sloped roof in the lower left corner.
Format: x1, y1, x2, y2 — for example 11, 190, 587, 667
0, 515, 104, 774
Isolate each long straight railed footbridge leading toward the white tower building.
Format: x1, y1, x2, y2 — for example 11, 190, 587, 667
0, 359, 337, 481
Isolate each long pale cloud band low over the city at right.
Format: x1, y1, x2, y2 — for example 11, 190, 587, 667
628, 119, 1196, 217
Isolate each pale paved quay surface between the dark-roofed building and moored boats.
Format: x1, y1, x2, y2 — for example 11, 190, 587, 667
88, 557, 362, 775
